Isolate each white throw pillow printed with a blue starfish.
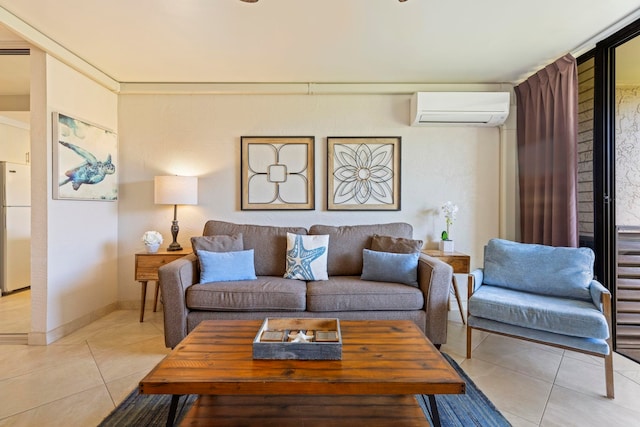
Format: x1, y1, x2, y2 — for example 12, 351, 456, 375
284, 233, 329, 280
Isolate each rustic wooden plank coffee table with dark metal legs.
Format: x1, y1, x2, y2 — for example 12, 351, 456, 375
140, 320, 465, 426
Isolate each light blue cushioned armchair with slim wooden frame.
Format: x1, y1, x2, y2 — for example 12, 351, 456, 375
467, 239, 614, 398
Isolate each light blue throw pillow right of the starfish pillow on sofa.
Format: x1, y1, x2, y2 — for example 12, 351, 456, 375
360, 249, 420, 287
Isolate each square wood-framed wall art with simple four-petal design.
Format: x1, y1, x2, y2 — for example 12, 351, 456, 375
240, 136, 315, 210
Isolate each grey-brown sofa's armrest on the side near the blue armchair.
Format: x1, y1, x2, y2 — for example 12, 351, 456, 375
418, 253, 453, 345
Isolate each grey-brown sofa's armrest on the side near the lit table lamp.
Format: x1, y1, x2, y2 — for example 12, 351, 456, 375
158, 254, 200, 348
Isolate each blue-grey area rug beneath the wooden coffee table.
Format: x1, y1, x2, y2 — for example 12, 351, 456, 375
99, 353, 511, 427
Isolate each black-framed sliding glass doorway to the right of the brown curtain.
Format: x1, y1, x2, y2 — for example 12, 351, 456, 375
578, 21, 640, 361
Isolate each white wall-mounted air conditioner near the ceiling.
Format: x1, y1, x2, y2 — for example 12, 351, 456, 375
410, 92, 509, 126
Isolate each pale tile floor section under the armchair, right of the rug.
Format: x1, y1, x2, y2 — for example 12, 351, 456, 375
442, 312, 640, 427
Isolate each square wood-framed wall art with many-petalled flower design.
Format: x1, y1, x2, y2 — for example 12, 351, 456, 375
327, 136, 402, 211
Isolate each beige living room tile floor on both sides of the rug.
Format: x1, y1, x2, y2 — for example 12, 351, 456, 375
0, 310, 640, 427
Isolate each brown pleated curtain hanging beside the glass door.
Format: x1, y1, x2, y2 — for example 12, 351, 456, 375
515, 55, 578, 247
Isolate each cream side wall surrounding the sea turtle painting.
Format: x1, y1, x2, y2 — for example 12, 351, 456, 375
29, 49, 118, 344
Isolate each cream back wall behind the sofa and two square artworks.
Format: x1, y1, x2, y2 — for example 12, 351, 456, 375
118, 94, 515, 307
